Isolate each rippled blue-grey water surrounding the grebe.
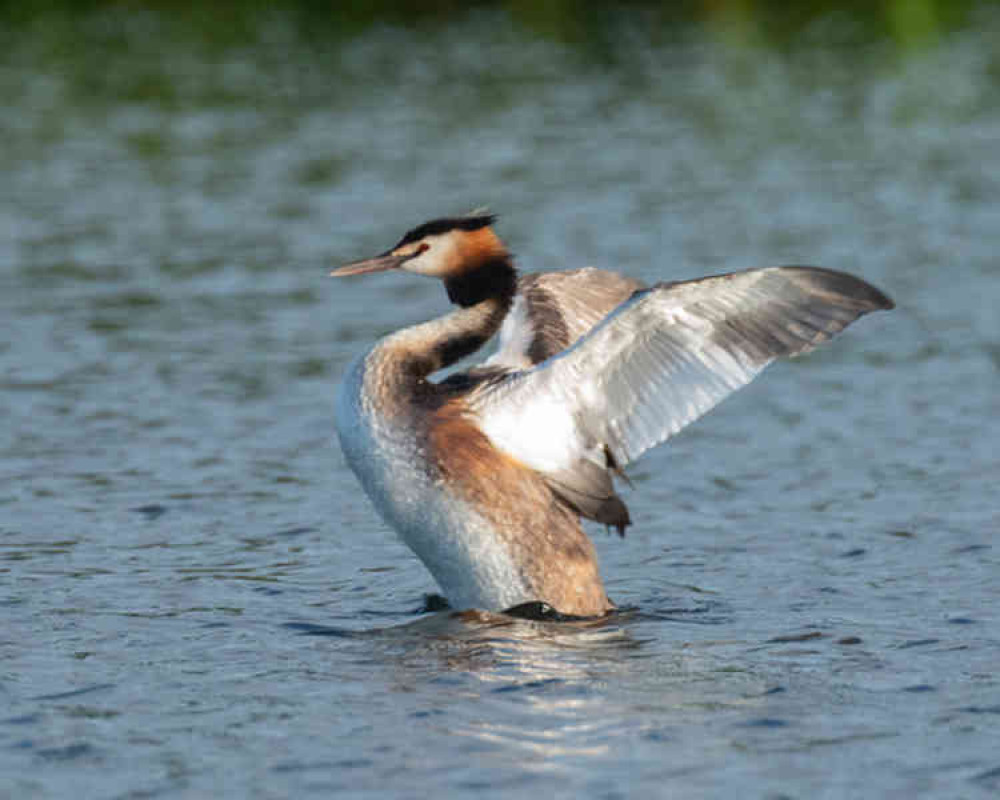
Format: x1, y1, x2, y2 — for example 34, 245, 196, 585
0, 6, 1000, 798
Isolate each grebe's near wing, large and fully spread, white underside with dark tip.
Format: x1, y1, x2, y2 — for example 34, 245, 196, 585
469, 267, 893, 518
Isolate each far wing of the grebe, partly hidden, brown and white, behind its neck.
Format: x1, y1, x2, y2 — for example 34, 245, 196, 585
483, 267, 645, 369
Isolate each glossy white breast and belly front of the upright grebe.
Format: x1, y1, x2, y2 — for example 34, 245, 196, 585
336, 354, 534, 609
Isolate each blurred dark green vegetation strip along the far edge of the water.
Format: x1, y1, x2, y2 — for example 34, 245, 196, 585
0, 0, 984, 52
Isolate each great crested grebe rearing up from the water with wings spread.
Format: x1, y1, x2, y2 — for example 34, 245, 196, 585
331, 213, 893, 616
